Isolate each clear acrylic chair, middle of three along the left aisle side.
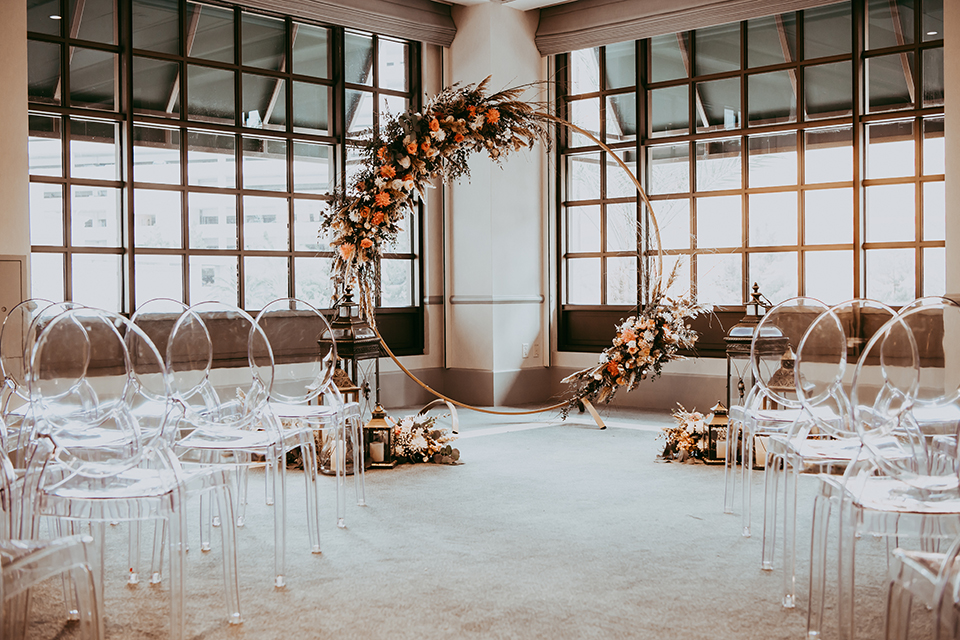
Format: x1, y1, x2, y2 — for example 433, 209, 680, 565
166, 302, 320, 588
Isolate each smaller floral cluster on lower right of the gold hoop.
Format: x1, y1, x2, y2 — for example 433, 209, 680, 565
562, 269, 701, 417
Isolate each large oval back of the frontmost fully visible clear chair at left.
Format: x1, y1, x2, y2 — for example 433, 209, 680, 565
27, 308, 169, 478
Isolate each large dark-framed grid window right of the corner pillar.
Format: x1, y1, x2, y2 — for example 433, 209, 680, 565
557, 0, 944, 350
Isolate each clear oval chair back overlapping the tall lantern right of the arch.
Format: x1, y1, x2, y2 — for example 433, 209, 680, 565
750, 296, 827, 409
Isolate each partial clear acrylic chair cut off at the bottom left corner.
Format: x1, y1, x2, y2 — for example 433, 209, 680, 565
0, 438, 103, 640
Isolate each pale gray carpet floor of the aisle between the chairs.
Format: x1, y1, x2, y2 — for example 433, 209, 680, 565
22, 411, 929, 640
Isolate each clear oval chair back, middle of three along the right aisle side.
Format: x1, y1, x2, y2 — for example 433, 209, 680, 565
796, 298, 896, 437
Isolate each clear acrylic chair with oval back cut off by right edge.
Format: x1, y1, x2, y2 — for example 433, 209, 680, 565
808, 298, 960, 640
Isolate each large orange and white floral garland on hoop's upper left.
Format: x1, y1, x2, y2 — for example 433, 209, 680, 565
321, 77, 549, 323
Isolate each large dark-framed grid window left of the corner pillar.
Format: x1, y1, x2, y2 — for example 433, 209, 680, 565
28, 0, 420, 311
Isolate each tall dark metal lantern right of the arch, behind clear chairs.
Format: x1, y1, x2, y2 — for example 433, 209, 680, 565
723, 283, 786, 407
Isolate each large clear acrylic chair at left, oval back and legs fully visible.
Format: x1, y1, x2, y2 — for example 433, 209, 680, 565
21, 309, 241, 640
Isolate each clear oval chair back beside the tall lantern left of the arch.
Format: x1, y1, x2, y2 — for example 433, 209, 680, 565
251, 298, 337, 404
